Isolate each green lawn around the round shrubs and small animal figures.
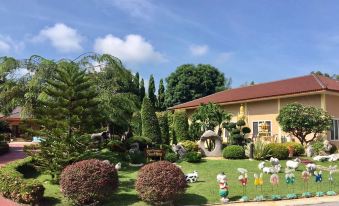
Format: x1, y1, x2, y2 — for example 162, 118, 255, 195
33, 160, 339, 205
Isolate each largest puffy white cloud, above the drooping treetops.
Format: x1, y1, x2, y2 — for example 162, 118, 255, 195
94, 34, 166, 63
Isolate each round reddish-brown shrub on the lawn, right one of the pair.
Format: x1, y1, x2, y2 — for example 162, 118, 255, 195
135, 161, 187, 203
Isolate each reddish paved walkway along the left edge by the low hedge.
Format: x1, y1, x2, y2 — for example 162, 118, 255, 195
0, 142, 31, 206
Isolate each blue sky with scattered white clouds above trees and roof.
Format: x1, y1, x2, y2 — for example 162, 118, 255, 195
0, 0, 339, 87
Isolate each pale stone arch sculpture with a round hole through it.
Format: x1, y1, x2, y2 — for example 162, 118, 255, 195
199, 130, 222, 157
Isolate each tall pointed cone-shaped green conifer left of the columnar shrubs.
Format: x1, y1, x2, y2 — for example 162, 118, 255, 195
141, 97, 162, 144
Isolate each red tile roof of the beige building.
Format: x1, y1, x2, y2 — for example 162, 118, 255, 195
170, 74, 339, 109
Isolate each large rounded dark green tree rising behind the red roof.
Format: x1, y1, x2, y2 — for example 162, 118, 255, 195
166, 64, 231, 107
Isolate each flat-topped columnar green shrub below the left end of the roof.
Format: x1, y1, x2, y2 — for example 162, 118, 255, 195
173, 110, 189, 141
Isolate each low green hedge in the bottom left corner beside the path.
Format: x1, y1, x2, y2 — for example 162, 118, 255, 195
0, 157, 45, 205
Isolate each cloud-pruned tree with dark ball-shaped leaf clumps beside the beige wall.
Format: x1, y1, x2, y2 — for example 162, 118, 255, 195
224, 120, 251, 146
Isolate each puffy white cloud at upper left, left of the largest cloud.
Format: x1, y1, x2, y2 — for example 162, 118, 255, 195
33, 23, 83, 53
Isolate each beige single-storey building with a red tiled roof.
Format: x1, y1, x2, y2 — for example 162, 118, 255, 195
170, 74, 339, 146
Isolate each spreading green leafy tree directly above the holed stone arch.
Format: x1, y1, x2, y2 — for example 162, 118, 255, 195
192, 103, 232, 136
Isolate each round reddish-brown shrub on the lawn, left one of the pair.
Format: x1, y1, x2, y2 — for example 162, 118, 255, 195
60, 159, 118, 205
